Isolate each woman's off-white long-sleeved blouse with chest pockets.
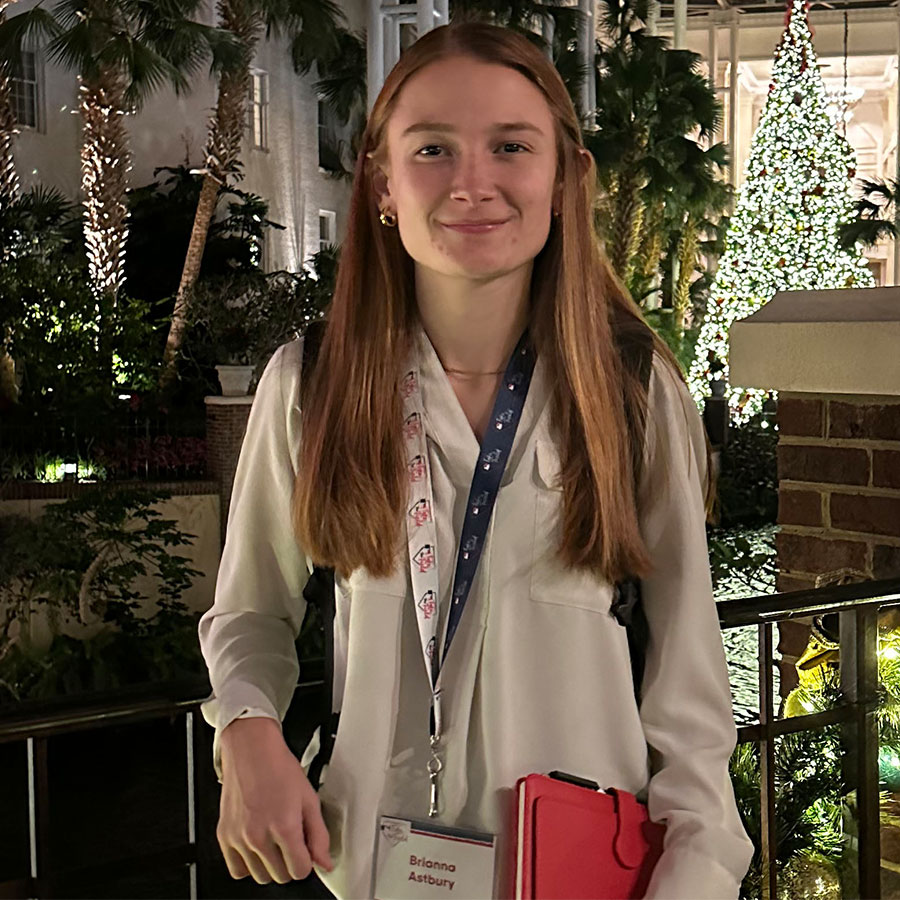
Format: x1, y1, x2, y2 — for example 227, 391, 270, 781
199, 328, 753, 900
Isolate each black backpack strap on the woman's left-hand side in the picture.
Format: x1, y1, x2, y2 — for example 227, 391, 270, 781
301, 320, 339, 790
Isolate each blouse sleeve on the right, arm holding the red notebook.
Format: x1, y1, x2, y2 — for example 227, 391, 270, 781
639, 358, 753, 900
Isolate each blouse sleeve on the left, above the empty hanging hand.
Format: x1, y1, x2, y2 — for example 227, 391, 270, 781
198, 341, 309, 781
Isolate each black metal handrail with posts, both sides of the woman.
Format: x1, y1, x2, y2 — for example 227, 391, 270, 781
0, 578, 900, 897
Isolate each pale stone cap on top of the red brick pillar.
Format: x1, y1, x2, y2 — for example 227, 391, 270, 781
729, 286, 900, 397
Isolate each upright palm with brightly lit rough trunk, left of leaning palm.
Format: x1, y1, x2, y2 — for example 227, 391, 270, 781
0, 0, 233, 307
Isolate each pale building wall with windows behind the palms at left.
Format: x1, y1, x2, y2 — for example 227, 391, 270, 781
9, 0, 366, 271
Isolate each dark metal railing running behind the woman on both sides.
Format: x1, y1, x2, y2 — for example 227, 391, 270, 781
0, 577, 900, 900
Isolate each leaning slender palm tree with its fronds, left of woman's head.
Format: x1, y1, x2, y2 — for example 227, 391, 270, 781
160, 0, 344, 387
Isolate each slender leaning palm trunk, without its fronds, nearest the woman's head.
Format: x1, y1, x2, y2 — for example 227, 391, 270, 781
160, 0, 263, 389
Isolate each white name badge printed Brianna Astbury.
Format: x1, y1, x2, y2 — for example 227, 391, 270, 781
373, 816, 494, 900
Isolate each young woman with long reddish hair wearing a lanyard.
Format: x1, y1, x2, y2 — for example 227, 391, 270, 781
200, 23, 752, 900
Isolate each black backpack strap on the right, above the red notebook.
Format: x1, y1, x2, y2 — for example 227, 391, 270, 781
610, 328, 653, 707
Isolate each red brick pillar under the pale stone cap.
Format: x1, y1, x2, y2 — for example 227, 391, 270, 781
776, 393, 900, 696
